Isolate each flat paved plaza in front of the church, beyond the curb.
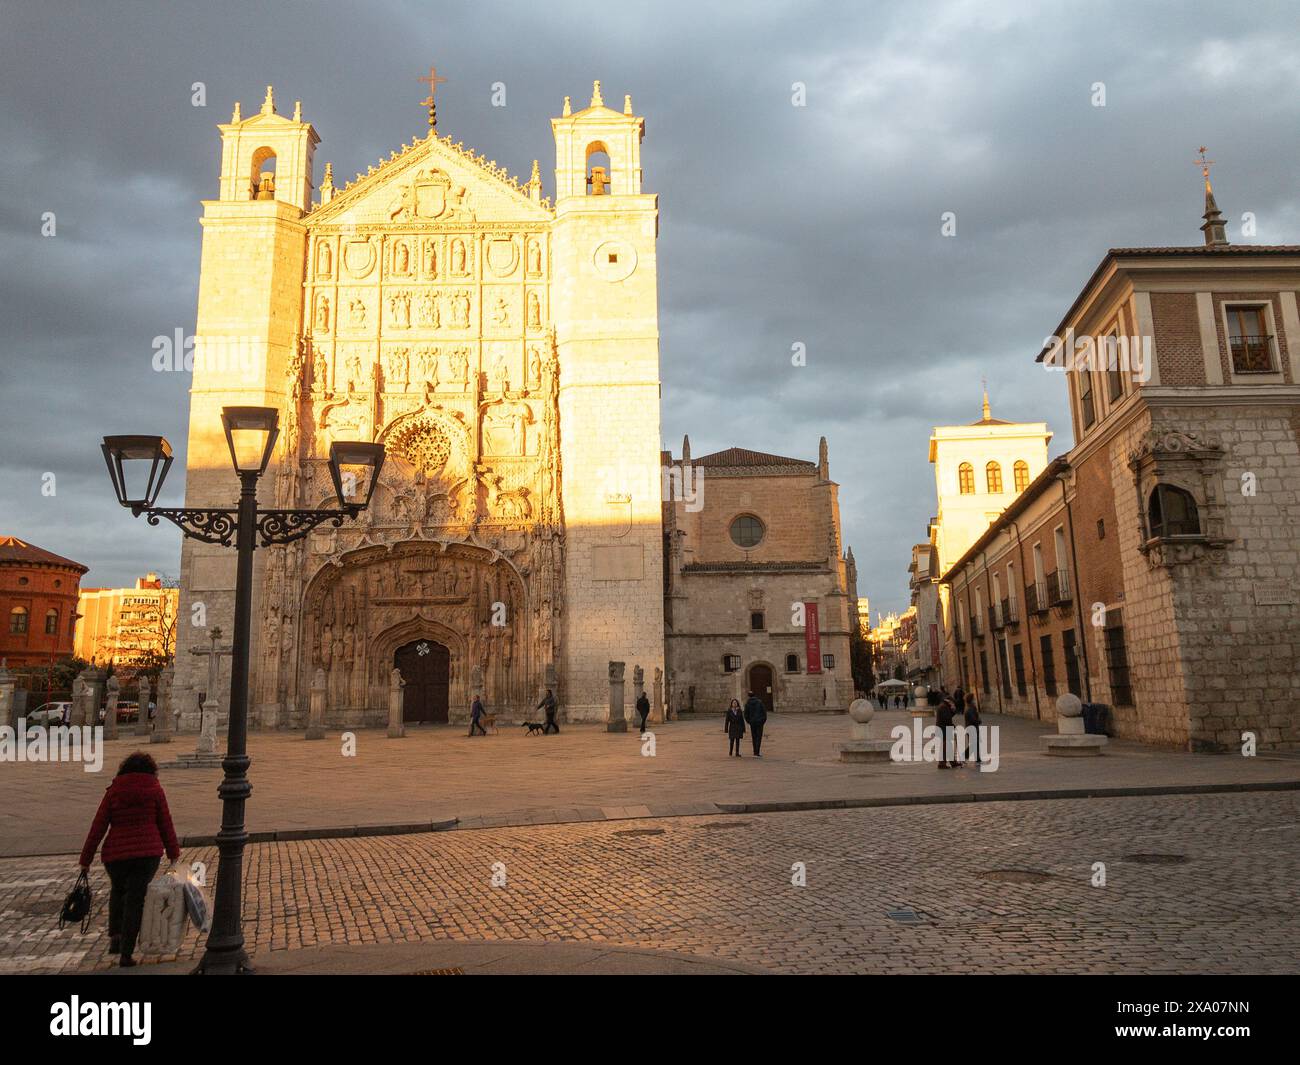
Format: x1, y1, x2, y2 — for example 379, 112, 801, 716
0, 711, 1300, 857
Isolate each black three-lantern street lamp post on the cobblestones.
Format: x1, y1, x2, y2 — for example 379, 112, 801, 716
103, 407, 384, 974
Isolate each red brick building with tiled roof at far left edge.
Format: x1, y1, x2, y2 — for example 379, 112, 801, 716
0, 536, 88, 666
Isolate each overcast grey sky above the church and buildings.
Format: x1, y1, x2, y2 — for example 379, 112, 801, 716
0, 0, 1300, 612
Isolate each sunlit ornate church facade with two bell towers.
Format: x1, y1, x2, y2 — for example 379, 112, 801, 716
174, 83, 663, 727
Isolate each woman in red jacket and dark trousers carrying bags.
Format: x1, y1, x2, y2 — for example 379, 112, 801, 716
81, 750, 181, 966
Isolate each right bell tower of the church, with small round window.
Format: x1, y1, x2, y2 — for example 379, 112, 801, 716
551, 82, 663, 719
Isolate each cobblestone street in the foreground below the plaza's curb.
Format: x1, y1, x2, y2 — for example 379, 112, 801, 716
0, 792, 1300, 973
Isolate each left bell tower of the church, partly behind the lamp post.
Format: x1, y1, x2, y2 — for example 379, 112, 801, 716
173, 86, 320, 727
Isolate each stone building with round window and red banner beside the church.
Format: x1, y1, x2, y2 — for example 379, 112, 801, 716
663, 438, 859, 714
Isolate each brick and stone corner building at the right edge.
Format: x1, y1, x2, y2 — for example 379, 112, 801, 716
944, 183, 1300, 750
